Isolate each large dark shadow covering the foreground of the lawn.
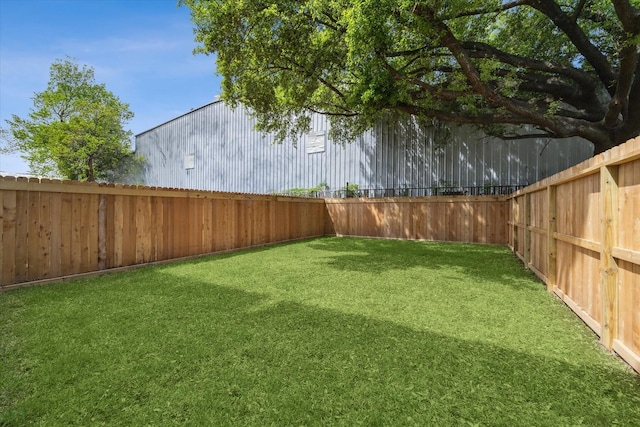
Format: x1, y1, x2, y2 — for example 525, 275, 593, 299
0, 270, 640, 426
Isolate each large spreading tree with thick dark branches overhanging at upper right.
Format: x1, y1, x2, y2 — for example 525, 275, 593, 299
181, 0, 640, 153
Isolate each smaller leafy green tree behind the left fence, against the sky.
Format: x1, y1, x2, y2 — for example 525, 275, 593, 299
4, 59, 140, 181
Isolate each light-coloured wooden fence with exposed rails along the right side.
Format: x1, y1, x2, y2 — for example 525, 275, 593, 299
509, 137, 640, 371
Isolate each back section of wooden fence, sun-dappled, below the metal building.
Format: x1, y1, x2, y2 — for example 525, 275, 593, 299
326, 196, 508, 245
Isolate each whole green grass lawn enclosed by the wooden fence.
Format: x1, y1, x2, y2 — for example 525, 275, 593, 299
0, 238, 640, 426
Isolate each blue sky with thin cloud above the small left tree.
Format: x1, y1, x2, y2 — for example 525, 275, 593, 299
0, 0, 220, 175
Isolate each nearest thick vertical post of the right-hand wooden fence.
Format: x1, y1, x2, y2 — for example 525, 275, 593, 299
600, 166, 618, 350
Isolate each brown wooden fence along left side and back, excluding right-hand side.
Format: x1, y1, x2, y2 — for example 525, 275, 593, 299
0, 177, 507, 290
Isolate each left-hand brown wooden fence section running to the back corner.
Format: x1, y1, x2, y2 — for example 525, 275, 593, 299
0, 177, 326, 289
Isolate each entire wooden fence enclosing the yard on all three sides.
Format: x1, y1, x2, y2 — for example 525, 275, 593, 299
0, 138, 640, 371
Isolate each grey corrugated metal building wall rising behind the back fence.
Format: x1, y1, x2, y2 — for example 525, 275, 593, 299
136, 101, 593, 193
